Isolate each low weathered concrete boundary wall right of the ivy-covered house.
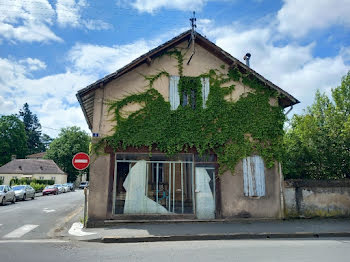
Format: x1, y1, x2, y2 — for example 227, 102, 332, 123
284, 180, 350, 217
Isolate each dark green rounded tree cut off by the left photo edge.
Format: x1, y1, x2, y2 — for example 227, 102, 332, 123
0, 115, 27, 166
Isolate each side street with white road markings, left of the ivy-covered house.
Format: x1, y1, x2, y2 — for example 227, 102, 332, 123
0, 190, 84, 241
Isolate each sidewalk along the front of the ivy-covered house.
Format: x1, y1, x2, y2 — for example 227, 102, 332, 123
70, 219, 350, 243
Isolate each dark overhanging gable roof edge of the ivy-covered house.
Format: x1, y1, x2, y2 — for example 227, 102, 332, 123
76, 30, 300, 129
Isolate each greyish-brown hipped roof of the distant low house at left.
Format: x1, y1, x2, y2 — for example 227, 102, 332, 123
0, 159, 64, 174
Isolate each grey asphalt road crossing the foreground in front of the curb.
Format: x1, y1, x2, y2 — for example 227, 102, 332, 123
0, 239, 350, 262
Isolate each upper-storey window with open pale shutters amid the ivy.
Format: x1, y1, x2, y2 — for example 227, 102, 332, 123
169, 76, 210, 110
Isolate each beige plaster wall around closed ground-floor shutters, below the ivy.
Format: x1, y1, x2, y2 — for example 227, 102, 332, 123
220, 161, 282, 218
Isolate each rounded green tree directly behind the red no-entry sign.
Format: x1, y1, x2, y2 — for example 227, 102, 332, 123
46, 126, 90, 182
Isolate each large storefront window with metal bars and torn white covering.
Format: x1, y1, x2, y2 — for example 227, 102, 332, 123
114, 154, 194, 215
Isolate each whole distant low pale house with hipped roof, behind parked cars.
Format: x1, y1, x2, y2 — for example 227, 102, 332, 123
0, 159, 67, 185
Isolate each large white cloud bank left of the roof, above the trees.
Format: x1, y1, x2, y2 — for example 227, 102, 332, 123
0, 58, 98, 136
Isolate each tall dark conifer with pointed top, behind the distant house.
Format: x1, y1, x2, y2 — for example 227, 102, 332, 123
19, 103, 45, 154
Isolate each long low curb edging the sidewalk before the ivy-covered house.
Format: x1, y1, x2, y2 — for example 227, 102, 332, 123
82, 232, 350, 243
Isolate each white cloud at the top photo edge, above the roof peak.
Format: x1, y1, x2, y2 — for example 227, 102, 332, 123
117, 0, 208, 13
